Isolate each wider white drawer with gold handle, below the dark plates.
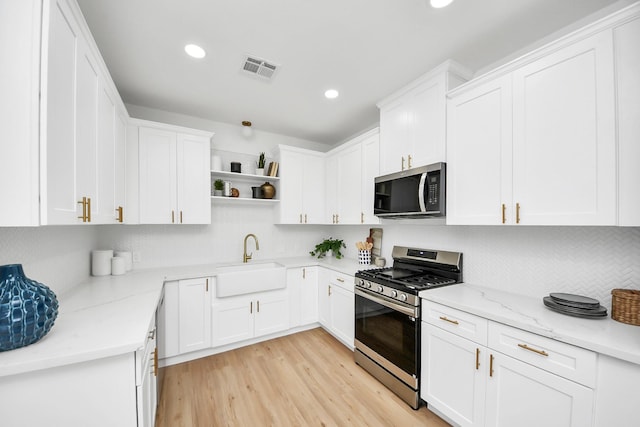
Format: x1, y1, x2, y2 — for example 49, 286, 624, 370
489, 322, 596, 388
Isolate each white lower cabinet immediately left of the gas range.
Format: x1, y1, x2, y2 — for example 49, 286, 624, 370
318, 267, 355, 349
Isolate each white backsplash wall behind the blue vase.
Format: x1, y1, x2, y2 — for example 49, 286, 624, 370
0, 226, 98, 295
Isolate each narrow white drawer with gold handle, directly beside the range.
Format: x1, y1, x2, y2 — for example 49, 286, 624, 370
422, 300, 488, 345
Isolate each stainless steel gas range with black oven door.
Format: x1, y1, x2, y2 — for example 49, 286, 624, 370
354, 246, 462, 409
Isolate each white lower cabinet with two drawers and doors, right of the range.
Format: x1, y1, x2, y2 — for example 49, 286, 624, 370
421, 301, 596, 427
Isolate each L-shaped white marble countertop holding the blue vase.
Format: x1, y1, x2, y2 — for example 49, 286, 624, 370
0, 256, 369, 377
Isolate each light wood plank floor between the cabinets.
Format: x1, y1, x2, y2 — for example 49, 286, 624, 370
156, 328, 448, 427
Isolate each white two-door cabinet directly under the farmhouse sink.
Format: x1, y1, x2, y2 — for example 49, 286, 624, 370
211, 289, 290, 347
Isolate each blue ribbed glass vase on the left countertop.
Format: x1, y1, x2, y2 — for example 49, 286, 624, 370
0, 264, 58, 351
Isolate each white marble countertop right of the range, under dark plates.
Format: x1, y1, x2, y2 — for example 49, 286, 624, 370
420, 283, 640, 364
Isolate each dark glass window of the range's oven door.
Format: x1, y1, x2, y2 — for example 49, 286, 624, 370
355, 295, 420, 377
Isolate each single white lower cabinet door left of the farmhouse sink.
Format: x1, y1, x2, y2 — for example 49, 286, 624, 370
178, 278, 211, 353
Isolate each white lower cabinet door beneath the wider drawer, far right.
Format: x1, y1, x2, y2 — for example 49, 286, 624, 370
486, 352, 594, 427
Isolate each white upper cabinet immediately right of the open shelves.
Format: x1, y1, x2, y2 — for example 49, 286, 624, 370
278, 145, 325, 224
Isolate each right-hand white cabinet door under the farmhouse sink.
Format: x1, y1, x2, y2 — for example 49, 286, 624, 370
254, 290, 290, 337
